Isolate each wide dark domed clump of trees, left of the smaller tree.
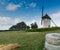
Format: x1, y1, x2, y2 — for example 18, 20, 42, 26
9, 22, 30, 30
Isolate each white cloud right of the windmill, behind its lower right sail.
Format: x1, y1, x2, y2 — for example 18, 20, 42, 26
50, 11, 60, 26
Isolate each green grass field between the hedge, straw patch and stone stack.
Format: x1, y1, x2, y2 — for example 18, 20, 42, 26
0, 30, 60, 50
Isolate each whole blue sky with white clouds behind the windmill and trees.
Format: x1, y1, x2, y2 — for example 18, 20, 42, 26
0, 0, 60, 30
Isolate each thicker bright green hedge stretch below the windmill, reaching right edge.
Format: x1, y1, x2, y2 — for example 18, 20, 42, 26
26, 27, 60, 32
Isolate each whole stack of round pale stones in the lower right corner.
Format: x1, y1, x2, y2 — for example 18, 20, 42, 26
43, 33, 60, 50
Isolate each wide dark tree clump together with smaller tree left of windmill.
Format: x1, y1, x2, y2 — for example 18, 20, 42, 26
9, 22, 38, 30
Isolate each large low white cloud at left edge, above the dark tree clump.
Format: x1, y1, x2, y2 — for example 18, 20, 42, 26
0, 16, 21, 30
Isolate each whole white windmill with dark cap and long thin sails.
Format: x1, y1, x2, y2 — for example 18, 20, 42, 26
41, 0, 57, 28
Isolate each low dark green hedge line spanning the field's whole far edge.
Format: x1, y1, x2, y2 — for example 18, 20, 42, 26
0, 27, 60, 32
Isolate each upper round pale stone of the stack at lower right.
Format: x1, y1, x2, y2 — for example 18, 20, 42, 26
46, 33, 60, 45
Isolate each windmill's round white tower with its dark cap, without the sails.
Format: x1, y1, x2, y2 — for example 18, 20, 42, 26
41, 14, 51, 28
